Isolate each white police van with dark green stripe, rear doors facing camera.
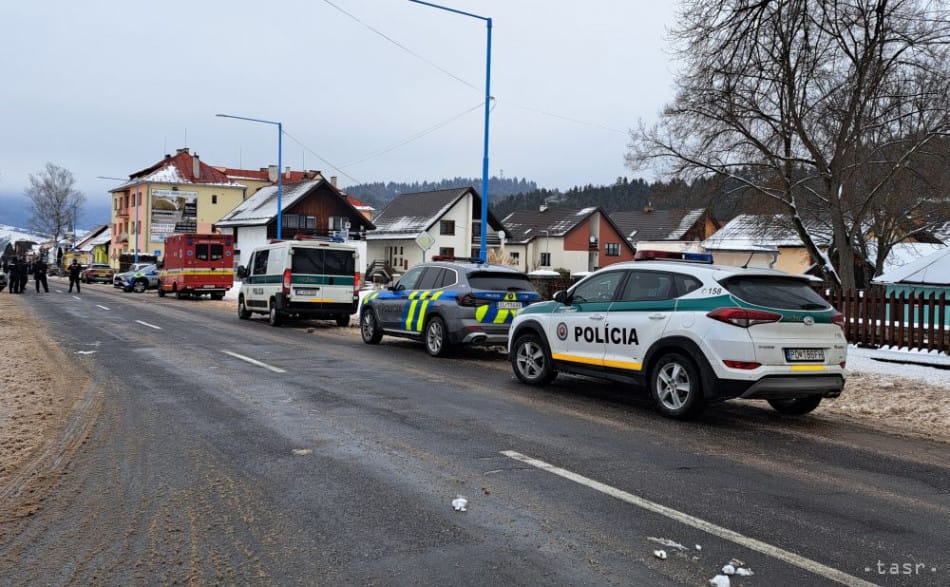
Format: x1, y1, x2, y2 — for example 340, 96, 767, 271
238, 240, 360, 326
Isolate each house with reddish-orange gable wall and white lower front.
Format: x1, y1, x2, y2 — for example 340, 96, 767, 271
502, 206, 634, 273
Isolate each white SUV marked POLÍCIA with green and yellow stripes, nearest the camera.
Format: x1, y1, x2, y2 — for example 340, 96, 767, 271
508, 251, 847, 418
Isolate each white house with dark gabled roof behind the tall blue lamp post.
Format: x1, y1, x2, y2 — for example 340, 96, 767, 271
366, 187, 503, 281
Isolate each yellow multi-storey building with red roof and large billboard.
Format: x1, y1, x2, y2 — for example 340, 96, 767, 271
109, 148, 247, 269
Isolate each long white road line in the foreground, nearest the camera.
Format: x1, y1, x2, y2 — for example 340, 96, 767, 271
501, 450, 874, 587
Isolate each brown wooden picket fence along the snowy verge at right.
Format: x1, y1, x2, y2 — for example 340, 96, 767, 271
823, 288, 950, 353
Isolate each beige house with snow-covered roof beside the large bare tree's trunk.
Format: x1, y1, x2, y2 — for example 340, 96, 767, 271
702, 214, 831, 274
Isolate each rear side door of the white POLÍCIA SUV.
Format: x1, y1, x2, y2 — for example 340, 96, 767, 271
604, 269, 676, 372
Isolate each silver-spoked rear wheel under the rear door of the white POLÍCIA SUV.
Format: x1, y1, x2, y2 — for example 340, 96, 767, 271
650, 353, 706, 420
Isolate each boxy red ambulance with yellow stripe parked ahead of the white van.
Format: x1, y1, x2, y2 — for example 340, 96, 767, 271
158, 233, 234, 300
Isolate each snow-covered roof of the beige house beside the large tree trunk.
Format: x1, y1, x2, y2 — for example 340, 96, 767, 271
703, 214, 831, 251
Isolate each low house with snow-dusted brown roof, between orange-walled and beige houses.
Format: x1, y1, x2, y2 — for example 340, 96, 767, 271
610, 207, 722, 250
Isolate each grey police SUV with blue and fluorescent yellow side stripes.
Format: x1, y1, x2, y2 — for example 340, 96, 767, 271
360, 256, 541, 357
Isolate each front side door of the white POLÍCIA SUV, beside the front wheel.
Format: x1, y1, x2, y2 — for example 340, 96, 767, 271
546, 270, 626, 367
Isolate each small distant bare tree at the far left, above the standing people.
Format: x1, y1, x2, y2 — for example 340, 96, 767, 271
26, 163, 86, 241
